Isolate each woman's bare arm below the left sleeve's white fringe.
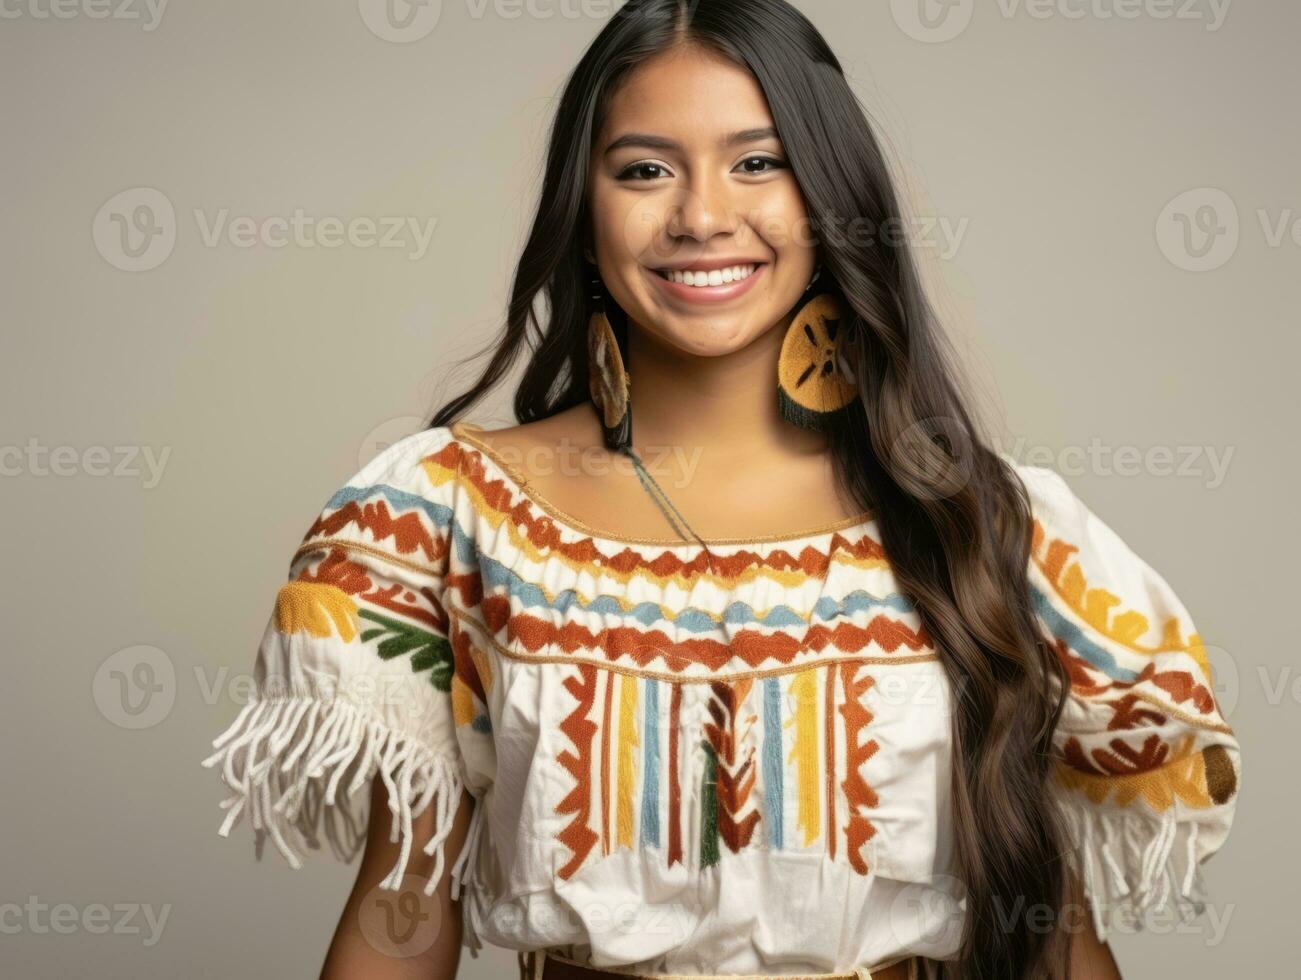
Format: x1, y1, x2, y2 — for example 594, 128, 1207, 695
320, 776, 475, 980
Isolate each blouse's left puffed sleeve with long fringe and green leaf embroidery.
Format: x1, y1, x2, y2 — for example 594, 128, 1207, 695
203, 428, 492, 894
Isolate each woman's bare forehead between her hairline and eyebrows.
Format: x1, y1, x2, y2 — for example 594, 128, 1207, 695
597, 46, 773, 150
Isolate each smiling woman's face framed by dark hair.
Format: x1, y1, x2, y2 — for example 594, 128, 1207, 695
588, 46, 816, 355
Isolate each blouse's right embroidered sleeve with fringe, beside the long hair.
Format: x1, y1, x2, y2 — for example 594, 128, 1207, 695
1013, 463, 1241, 940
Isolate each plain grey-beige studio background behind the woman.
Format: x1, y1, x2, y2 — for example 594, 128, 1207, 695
0, 0, 1301, 977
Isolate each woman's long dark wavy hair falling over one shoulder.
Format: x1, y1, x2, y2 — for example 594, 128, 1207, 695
429, 0, 1068, 979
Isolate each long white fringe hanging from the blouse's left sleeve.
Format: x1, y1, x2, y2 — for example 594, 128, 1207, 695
203, 696, 465, 895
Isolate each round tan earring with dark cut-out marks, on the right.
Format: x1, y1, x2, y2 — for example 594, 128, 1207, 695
777, 293, 859, 428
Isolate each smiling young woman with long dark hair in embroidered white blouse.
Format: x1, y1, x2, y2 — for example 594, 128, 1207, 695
206, 0, 1240, 979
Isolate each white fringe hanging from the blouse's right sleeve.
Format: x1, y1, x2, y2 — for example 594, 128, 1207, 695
1059, 794, 1206, 941
